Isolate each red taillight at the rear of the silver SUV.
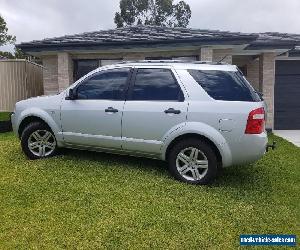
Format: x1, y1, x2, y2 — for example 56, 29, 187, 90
245, 108, 265, 134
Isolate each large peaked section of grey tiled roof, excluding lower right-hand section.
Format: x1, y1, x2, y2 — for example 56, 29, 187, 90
19, 25, 257, 48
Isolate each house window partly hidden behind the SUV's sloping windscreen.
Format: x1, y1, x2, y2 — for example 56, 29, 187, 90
73, 59, 122, 81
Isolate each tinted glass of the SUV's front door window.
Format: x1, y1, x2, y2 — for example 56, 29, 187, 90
77, 68, 130, 100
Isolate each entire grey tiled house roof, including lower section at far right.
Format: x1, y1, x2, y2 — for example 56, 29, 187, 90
17, 25, 300, 50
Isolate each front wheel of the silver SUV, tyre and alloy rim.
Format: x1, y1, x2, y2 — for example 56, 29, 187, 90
21, 122, 57, 160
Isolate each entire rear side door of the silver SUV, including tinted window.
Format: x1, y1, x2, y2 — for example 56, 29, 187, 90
122, 67, 188, 154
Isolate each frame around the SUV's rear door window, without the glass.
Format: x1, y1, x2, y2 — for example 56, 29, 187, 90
126, 67, 185, 102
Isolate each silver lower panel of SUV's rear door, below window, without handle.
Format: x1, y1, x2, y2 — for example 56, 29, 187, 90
122, 101, 187, 154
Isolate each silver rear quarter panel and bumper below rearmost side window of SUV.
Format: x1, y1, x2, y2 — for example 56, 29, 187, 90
187, 100, 267, 165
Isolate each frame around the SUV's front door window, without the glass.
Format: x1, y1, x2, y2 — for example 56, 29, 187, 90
73, 66, 134, 101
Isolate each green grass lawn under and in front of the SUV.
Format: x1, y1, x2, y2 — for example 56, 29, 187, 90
0, 133, 300, 249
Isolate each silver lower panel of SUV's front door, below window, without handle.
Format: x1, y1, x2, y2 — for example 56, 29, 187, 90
61, 100, 124, 148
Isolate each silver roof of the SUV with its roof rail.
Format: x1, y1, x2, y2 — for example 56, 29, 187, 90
111, 60, 237, 71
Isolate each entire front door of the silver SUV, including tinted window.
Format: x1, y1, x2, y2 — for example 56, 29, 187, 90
61, 68, 130, 149
